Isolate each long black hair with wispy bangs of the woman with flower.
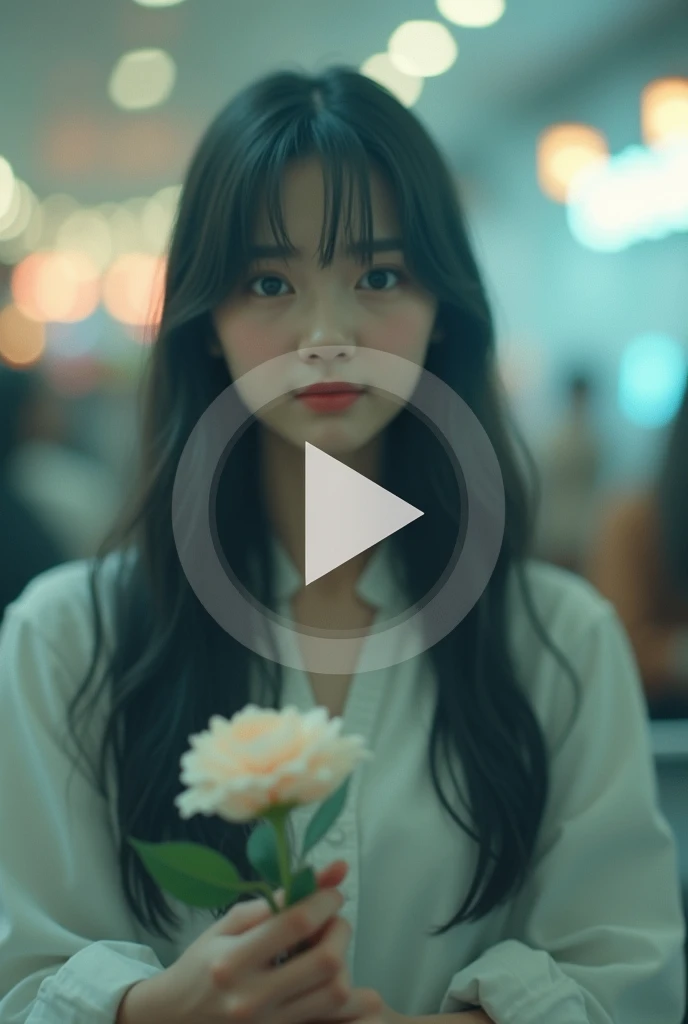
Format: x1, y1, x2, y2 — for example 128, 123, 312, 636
64, 68, 575, 937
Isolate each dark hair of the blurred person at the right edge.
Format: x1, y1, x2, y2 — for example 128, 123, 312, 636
656, 377, 688, 598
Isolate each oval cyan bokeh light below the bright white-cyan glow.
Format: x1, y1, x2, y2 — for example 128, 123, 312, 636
617, 334, 688, 428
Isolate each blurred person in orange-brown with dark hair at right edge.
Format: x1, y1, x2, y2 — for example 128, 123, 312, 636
586, 381, 688, 718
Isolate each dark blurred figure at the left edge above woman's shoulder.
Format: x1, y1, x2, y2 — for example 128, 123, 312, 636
0, 366, 67, 618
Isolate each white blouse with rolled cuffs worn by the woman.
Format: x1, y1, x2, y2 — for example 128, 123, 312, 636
0, 544, 685, 1024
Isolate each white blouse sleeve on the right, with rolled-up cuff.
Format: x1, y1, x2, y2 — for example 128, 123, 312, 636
439, 602, 686, 1024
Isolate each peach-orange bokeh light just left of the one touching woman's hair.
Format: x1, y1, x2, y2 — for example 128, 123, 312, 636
12, 251, 100, 324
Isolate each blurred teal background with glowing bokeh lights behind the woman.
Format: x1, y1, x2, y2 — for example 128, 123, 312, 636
0, 0, 688, 999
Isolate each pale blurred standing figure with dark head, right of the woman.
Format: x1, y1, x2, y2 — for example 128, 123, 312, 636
535, 374, 601, 572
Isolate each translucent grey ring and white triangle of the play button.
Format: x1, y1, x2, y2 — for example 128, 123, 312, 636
172, 348, 506, 675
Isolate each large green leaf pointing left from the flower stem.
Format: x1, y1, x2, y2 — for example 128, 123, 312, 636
128, 839, 246, 908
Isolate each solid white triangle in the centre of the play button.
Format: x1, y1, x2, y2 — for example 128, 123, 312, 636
305, 441, 424, 586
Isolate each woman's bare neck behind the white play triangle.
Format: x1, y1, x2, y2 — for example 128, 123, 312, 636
260, 425, 382, 597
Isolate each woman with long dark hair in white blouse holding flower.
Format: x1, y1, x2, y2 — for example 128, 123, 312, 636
0, 69, 685, 1024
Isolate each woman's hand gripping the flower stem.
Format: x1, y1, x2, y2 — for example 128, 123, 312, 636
117, 861, 351, 1024
